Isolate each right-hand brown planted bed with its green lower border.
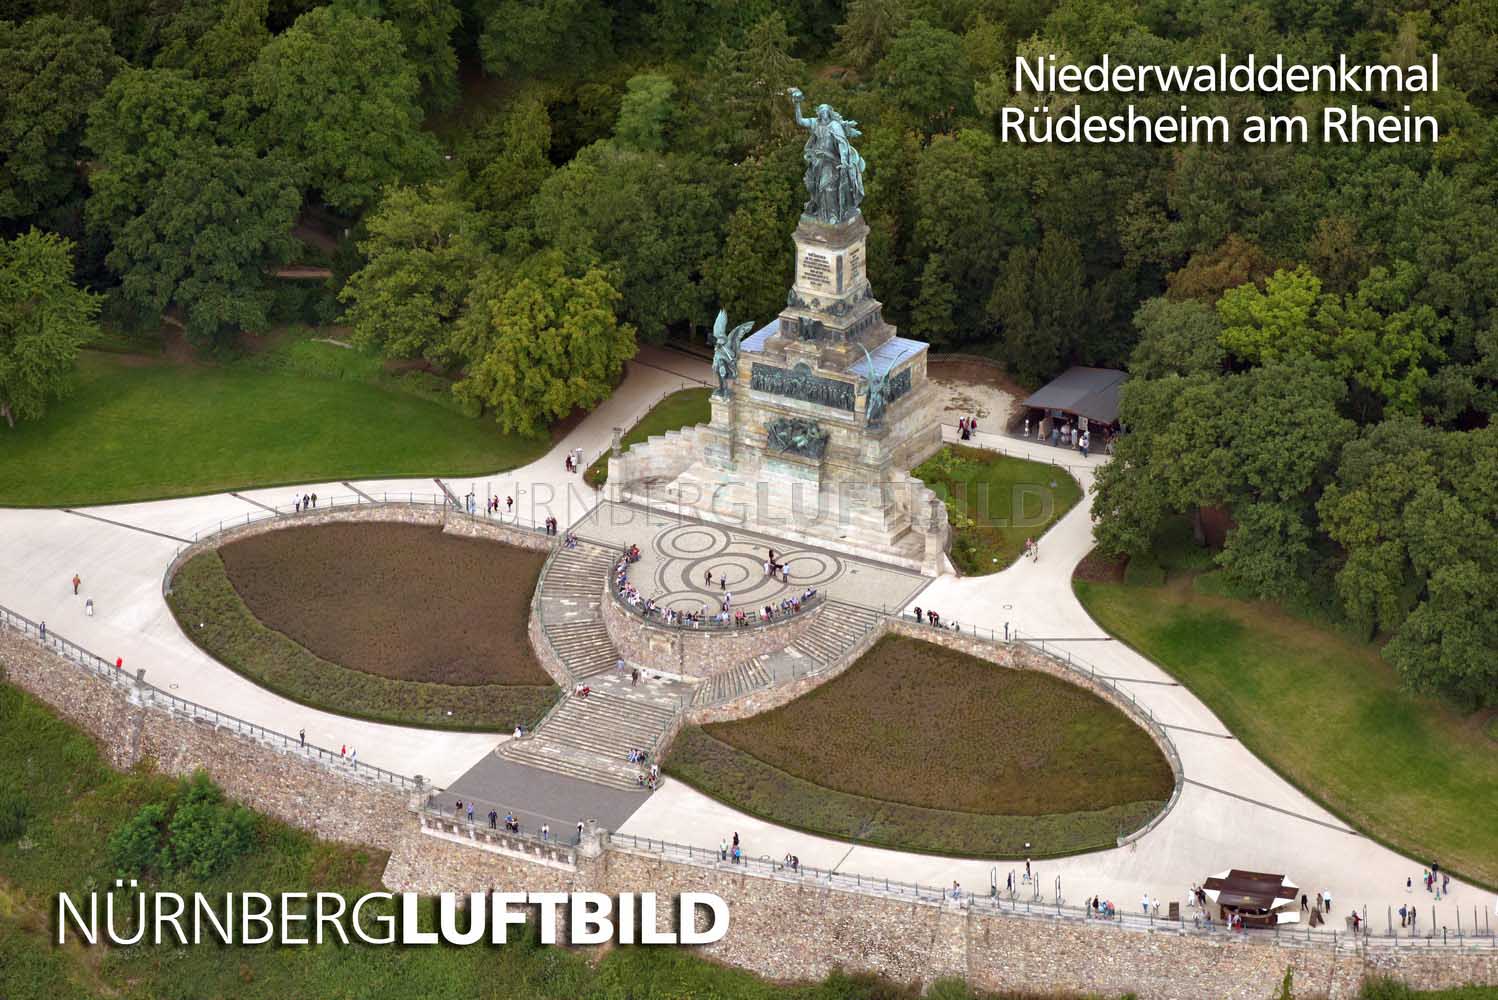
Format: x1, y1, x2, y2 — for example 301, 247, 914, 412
667, 636, 1174, 858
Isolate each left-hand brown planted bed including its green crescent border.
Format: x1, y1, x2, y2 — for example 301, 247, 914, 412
168, 522, 557, 731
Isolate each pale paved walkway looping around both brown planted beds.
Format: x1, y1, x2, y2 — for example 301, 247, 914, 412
0, 357, 1494, 930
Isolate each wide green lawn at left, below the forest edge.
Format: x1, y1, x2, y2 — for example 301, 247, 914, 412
0, 350, 550, 506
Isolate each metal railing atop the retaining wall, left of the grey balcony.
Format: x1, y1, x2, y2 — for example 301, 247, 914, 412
0, 606, 422, 789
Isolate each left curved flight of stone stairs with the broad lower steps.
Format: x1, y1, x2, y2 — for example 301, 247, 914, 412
499, 540, 691, 789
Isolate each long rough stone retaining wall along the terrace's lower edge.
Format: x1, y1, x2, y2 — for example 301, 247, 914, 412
0, 626, 1498, 1000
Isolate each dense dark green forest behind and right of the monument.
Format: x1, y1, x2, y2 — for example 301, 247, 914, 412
0, 0, 1498, 705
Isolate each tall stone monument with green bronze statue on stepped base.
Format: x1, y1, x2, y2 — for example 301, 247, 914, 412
605, 91, 948, 576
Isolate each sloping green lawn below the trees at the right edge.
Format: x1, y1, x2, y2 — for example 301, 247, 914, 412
1076, 567, 1498, 886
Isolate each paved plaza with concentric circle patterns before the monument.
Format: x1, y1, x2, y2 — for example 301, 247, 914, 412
572, 503, 930, 614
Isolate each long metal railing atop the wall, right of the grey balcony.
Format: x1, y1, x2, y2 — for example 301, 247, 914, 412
608, 832, 1498, 949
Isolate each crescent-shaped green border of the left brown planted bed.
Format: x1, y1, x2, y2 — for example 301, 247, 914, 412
166, 552, 557, 732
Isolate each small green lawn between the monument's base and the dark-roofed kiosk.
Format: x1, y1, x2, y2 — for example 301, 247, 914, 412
911, 445, 1082, 575
